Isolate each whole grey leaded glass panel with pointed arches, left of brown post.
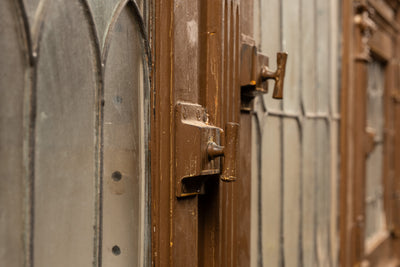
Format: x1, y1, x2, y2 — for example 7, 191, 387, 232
0, 0, 150, 266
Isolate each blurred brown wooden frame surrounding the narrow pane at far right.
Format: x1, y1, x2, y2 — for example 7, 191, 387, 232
339, 0, 400, 266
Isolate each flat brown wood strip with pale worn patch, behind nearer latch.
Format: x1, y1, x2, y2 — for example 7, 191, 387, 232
172, 0, 200, 266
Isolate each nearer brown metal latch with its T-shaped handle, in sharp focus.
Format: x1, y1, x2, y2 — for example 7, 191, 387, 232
175, 103, 239, 197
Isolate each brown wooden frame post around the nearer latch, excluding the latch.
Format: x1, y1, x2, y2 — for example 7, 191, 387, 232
149, 0, 252, 266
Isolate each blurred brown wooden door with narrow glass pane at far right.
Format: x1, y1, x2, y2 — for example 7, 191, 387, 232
341, 1, 399, 266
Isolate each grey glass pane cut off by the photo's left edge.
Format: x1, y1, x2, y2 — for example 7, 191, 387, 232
0, 0, 29, 267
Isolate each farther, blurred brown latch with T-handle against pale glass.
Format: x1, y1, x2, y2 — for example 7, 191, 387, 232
240, 43, 288, 109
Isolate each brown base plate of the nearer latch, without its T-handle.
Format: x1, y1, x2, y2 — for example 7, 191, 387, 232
175, 103, 223, 197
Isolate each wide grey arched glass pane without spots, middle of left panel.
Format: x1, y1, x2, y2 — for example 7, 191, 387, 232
34, 1, 100, 266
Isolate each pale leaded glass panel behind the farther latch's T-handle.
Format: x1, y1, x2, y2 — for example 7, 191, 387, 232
252, 0, 340, 266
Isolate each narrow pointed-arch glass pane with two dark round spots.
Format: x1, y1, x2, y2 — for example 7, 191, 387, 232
102, 5, 145, 266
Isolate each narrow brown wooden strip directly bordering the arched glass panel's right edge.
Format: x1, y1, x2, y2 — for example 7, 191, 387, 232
151, 1, 174, 266
